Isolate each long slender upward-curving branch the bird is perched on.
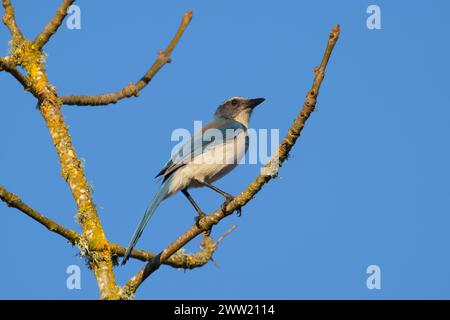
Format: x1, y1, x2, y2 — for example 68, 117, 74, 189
122, 25, 340, 296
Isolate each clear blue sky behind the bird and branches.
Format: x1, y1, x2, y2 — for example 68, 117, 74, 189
0, 0, 450, 299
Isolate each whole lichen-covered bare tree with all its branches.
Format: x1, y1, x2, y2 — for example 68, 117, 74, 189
0, 0, 340, 299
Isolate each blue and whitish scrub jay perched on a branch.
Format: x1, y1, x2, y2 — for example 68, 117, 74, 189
122, 97, 265, 265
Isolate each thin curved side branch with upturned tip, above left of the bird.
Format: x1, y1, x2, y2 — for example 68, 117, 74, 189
61, 12, 192, 106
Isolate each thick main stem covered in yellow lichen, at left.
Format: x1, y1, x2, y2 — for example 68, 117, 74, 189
2, 0, 119, 299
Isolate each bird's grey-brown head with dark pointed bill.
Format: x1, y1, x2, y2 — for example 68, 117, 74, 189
214, 97, 265, 127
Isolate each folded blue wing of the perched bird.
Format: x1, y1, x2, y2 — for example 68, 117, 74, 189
155, 118, 247, 181
